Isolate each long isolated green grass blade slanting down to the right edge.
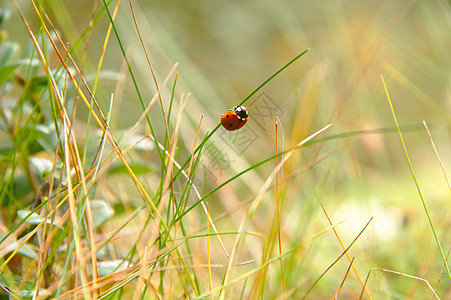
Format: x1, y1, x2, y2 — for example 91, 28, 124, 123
381, 74, 451, 278
